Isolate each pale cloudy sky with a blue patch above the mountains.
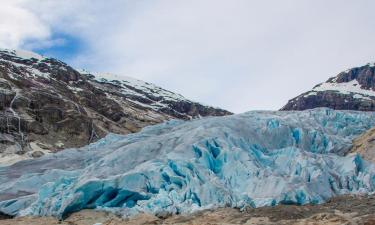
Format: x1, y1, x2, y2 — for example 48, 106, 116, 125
0, 0, 375, 113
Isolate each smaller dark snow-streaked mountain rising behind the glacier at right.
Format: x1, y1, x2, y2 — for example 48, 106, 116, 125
281, 63, 375, 111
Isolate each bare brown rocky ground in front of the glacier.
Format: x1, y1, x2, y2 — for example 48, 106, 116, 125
0, 195, 375, 225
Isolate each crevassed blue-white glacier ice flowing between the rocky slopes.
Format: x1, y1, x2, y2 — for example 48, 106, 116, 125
0, 108, 375, 218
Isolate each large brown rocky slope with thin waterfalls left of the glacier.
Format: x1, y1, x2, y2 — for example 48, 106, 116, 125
0, 50, 231, 163
